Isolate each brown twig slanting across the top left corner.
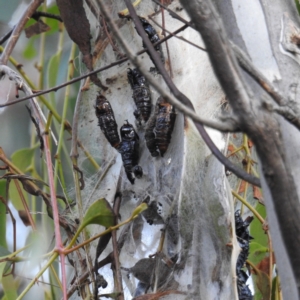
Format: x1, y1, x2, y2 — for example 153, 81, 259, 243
0, 0, 43, 65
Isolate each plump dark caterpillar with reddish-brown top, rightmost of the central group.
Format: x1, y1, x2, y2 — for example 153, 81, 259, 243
145, 97, 176, 157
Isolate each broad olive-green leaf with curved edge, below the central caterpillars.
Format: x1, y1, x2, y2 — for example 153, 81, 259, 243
78, 198, 115, 231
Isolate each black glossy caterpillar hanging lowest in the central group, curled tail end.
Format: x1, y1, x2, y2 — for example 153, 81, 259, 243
118, 121, 143, 184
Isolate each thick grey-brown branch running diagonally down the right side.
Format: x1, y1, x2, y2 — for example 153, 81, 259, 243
181, 0, 300, 295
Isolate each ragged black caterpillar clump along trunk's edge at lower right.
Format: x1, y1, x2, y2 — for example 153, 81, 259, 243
234, 210, 253, 300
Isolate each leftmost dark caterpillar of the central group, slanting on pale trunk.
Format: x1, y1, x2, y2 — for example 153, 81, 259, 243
95, 94, 120, 149
